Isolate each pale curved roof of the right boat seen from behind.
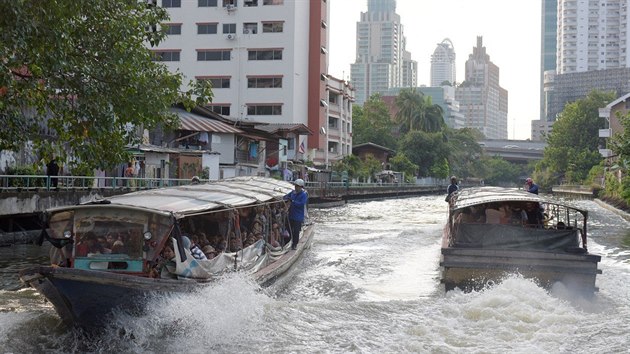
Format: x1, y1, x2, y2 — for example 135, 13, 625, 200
451, 187, 586, 213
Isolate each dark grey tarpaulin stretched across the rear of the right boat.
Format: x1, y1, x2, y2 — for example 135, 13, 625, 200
453, 223, 580, 251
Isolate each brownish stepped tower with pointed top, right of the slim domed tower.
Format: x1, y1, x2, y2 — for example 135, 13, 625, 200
455, 37, 508, 139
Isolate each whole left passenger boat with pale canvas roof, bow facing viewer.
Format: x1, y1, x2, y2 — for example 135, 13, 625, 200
20, 177, 313, 330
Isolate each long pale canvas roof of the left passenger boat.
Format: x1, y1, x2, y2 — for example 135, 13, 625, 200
50, 176, 294, 218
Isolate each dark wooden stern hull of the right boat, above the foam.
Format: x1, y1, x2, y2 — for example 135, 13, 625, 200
440, 248, 601, 296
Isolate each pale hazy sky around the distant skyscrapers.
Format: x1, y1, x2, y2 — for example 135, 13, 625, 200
328, 0, 542, 140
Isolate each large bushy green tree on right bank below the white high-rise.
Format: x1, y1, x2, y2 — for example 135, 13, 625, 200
536, 91, 615, 184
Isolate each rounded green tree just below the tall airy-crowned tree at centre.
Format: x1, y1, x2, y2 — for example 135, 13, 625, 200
399, 131, 450, 177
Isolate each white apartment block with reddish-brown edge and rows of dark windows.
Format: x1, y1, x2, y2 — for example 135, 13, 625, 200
151, 0, 341, 165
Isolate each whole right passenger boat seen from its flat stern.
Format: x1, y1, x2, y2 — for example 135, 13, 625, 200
440, 187, 601, 296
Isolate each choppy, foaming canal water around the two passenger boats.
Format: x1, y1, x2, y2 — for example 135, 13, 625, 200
0, 196, 630, 353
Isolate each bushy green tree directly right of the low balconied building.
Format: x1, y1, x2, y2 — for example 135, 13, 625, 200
352, 94, 396, 149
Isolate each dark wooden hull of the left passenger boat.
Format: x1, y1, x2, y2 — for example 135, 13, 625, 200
20, 225, 314, 331
